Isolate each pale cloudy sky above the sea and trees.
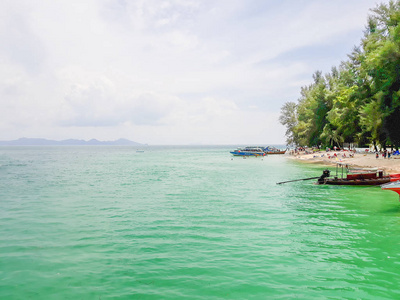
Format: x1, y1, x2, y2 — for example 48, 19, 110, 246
0, 0, 387, 145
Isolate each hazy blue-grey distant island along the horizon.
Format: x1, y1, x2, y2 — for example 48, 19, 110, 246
0, 138, 146, 146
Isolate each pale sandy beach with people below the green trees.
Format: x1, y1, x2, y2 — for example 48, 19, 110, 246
286, 151, 400, 174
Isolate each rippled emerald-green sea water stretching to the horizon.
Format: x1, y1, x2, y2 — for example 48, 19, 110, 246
0, 146, 400, 299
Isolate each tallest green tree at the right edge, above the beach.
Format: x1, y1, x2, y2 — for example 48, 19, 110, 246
361, 1, 400, 146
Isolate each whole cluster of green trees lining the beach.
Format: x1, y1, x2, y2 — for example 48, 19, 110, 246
279, 0, 400, 149
